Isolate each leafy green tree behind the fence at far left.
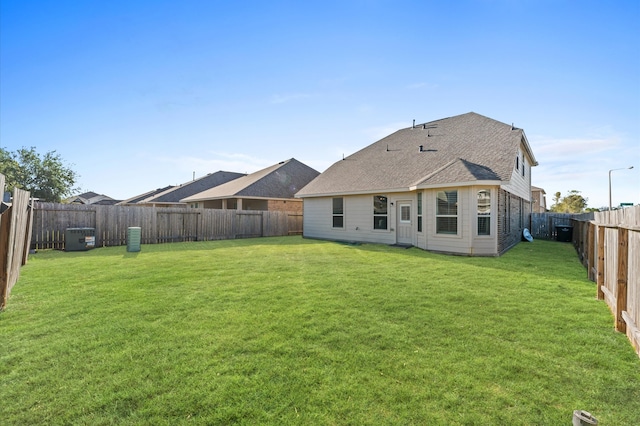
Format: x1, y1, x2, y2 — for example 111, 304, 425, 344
0, 147, 78, 202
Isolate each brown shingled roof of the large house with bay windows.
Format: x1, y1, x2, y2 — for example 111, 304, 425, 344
296, 112, 538, 197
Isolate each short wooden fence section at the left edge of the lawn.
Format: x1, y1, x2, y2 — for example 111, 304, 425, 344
0, 174, 32, 310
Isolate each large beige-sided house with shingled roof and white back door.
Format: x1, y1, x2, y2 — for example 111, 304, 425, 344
296, 112, 538, 256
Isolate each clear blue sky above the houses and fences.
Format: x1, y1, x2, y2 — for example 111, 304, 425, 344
0, 0, 640, 207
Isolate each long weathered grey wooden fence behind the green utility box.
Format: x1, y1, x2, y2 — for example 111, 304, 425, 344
31, 203, 302, 249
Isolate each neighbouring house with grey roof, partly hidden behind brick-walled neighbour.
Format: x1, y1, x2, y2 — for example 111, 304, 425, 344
120, 171, 246, 207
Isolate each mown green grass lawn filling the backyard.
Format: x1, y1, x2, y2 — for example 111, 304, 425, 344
0, 237, 640, 425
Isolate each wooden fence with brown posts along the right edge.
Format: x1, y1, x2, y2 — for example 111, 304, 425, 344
572, 206, 640, 356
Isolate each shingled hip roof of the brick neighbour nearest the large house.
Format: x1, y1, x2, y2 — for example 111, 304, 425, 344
181, 158, 320, 203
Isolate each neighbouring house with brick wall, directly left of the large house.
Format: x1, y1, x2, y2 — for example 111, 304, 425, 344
181, 158, 320, 213
